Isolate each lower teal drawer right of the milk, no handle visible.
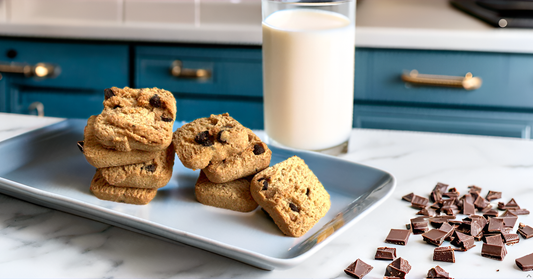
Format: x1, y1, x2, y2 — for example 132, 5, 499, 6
354, 106, 533, 139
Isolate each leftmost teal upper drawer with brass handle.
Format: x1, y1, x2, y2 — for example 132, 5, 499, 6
0, 39, 129, 89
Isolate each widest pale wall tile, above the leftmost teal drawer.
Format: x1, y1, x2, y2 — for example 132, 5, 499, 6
5, 0, 123, 23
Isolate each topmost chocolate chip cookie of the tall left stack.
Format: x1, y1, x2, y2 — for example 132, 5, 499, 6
94, 87, 176, 151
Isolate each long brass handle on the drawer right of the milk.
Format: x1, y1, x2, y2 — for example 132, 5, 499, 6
402, 70, 483, 90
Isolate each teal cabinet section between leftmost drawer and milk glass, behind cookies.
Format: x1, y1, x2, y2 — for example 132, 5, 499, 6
134, 45, 263, 129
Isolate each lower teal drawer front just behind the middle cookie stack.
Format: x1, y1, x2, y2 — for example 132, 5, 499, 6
176, 97, 263, 129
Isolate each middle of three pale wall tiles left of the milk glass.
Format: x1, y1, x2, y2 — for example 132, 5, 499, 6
124, 0, 199, 24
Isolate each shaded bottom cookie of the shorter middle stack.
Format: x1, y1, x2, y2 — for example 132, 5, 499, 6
194, 171, 257, 212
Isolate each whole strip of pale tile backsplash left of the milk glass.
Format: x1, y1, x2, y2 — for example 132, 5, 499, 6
0, 0, 261, 26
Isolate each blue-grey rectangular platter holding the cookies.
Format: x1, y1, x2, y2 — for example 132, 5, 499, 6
0, 119, 396, 270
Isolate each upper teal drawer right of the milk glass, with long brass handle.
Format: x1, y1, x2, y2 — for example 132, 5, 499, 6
355, 48, 533, 109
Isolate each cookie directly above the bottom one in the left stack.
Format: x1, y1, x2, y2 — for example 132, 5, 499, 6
101, 144, 176, 189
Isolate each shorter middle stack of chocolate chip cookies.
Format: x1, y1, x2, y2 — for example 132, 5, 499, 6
173, 113, 272, 212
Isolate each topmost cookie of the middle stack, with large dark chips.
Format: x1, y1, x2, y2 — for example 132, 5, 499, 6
173, 113, 248, 169
